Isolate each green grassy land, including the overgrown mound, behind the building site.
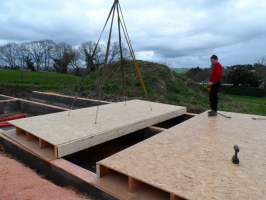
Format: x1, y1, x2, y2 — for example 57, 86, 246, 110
0, 61, 266, 115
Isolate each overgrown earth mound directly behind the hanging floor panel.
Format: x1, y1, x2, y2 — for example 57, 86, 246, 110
72, 61, 207, 112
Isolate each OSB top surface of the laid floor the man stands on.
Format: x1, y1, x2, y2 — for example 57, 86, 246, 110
98, 113, 266, 200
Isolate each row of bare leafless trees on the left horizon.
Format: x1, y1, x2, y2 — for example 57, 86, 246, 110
0, 40, 129, 74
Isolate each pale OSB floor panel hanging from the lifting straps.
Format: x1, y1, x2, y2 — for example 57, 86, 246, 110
10, 100, 186, 157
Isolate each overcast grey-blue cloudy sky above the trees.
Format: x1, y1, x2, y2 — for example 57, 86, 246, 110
0, 0, 266, 67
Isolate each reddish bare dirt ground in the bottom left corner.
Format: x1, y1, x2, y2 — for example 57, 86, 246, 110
0, 151, 89, 200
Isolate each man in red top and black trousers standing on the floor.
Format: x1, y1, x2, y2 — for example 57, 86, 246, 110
208, 55, 223, 117
